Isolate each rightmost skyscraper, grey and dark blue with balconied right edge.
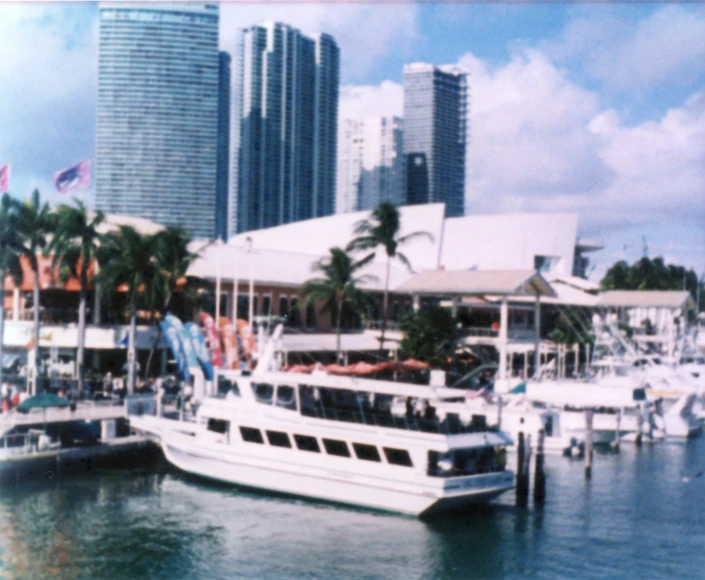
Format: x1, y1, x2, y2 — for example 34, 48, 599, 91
404, 63, 467, 217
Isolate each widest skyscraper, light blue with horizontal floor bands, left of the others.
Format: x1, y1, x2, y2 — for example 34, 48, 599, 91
96, 3, 219, 238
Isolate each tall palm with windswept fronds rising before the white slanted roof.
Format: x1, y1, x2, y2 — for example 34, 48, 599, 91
346, 201, 433, 350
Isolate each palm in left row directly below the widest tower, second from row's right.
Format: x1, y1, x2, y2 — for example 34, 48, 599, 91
96, 226, 158, 394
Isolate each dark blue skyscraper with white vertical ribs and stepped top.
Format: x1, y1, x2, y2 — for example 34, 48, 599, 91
237, 22, 340, 232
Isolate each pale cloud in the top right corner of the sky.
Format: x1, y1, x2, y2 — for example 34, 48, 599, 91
545, 5, 705, 90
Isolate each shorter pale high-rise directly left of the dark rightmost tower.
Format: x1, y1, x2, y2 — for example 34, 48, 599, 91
336, 116, 406, 213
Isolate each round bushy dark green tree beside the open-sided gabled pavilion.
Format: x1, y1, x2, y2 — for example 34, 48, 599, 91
399, 305, 459, 366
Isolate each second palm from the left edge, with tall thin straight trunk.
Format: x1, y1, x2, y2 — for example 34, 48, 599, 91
17, 189, 55, 392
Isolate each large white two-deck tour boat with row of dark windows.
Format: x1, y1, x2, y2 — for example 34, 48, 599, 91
131, 371, 514, 516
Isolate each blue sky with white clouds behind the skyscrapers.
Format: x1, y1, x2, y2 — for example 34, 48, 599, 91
0, 2, 705, 280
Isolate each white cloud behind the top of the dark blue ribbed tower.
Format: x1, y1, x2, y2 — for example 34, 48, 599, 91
220, 3, 419, 82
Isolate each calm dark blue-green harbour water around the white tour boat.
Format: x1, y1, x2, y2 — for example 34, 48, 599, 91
0, 437, 705, 579
